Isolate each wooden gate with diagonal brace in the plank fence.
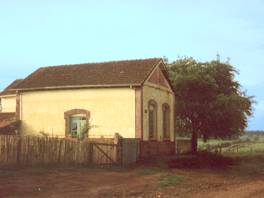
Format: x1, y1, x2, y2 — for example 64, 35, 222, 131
91, 142, 121, 165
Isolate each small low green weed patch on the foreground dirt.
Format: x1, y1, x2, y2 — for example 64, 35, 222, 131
158, 174, 187, 187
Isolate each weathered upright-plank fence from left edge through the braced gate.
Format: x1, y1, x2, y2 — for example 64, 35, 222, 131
0, 135, 121, 165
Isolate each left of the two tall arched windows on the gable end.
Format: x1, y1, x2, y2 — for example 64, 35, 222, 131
148, 100, 157, 140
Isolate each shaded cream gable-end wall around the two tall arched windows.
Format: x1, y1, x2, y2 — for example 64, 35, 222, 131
143, 82, 174, 141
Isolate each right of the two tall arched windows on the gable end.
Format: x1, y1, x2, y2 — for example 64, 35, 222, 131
162, 103, 170, 140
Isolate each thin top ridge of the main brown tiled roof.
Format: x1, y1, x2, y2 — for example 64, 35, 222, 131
39, 57, 162, 69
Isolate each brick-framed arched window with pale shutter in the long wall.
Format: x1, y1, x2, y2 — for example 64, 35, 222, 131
64, 109, 90, 138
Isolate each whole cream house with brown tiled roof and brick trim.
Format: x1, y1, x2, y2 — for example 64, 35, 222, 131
1, 58, 175, 141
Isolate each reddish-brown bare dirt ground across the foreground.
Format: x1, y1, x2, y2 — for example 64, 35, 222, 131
0, 155, 264, 198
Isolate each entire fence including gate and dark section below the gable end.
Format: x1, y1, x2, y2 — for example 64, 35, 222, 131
0, 134, 179, 166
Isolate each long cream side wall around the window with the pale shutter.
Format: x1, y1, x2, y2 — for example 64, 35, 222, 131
20, 88, 135, 138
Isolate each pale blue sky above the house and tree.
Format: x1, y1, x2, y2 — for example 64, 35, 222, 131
0, 0, 264, 130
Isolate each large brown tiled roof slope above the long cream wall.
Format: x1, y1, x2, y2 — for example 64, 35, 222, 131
16, 58, 162, 90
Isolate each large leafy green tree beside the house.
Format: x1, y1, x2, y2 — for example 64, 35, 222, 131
168, 58, 253, 153
